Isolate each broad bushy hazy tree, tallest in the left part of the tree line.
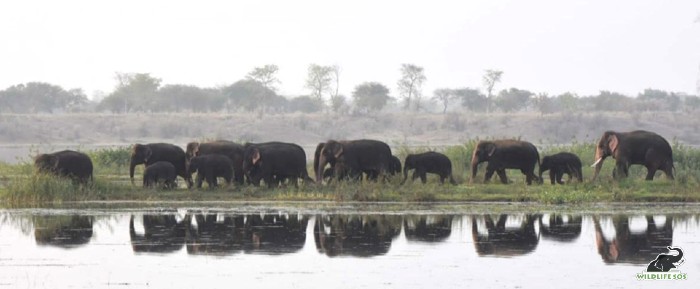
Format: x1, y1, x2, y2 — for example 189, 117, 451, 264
99, 72, 161, 113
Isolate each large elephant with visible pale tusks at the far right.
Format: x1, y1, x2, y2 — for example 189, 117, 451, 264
592, 130, 674, 181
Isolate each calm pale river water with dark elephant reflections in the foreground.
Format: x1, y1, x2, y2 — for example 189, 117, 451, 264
0, 204, 700, 288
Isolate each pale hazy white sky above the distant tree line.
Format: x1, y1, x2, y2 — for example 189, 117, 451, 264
0, 0, 700, 99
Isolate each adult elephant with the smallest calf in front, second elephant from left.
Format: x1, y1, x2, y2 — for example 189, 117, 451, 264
129, 143, 192, 188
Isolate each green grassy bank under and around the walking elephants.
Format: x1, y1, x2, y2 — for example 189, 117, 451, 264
0, 140, 700, 207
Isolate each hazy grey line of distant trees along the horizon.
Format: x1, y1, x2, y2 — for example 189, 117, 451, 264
0, 64, 700, 114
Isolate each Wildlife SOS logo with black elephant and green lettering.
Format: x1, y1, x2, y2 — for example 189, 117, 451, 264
637, 246, 688, 280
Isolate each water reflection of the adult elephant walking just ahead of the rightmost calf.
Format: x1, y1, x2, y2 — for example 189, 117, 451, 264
472, 214, 540, 257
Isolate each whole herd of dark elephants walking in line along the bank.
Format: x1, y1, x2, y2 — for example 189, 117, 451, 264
34, 130, 674, 188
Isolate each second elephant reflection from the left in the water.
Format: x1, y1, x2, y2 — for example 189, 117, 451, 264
129, 213, 191, 253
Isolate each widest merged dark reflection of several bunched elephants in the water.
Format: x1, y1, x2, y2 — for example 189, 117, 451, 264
186, 214, 308, 255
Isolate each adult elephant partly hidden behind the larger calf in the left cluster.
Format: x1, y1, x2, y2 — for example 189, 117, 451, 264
185, 140, 245, 185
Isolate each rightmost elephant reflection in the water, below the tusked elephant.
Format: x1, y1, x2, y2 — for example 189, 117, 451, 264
593, 215, 673, 264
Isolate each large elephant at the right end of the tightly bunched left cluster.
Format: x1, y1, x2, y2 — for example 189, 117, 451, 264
243, 142, 313, 188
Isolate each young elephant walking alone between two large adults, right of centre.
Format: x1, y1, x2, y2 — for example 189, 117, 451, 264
401, 152, 457, 185
